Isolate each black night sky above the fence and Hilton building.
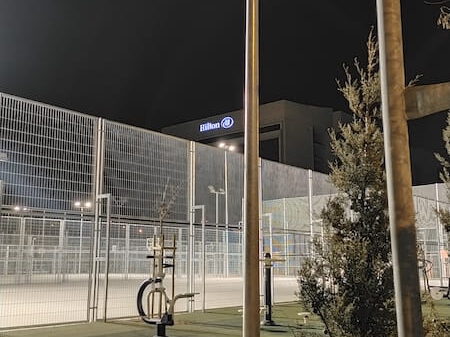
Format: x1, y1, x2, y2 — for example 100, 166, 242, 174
0, 0, 450, 182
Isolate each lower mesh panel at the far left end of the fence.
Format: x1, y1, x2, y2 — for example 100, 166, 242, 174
0, 216, 91, 327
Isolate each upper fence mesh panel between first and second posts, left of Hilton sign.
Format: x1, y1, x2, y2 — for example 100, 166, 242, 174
102, 121, 189, 221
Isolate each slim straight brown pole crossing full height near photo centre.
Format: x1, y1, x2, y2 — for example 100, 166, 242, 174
243, 0, 260, 337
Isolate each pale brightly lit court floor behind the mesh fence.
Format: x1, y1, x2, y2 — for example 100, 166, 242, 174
0, 278, 297, 328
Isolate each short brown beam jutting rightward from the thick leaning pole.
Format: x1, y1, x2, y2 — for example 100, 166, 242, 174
405, 82, 450, 119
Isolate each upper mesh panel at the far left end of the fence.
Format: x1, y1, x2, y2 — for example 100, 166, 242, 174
0, 94, 97, 211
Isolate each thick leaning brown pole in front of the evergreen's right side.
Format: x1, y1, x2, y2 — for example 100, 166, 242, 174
377, 0, 423, 337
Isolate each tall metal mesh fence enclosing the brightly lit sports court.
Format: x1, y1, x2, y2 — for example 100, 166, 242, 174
0, 94, 448, 328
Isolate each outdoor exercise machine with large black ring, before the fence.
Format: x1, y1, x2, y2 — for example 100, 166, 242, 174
137, 235, 195, 337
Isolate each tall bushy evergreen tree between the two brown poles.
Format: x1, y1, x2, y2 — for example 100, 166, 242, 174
298, 32, 396, 337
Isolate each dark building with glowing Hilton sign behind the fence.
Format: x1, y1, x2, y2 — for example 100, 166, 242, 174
162, 100, 351, 172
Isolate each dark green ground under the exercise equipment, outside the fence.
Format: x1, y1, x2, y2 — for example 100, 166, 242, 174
0, 299, 450, 337
